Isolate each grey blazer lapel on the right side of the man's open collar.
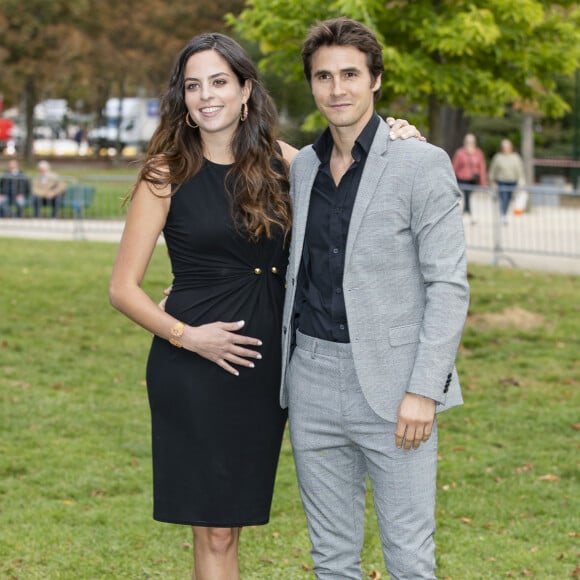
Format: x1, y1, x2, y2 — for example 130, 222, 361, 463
344, 121, 389, 269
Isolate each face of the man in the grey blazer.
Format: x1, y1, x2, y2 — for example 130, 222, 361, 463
311, 46, 381, 134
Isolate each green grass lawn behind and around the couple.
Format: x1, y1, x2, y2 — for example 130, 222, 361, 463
0, 239, 580, 580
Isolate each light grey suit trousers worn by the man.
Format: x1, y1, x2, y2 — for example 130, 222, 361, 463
287, 333, 437, 580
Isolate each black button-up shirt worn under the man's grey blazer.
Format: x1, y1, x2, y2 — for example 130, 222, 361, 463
295, 113, 380, 342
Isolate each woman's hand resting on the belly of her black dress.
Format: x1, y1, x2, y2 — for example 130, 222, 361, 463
182, 320, 262, 376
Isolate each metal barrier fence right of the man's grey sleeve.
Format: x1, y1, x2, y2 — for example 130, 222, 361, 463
461, 185, 580, 264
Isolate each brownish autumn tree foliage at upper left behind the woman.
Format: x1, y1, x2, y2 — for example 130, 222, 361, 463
0, 0, 243, 157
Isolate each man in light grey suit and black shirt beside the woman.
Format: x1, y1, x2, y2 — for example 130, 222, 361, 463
280, 18, 469, 580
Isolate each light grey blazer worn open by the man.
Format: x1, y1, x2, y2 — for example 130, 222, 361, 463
280, 121, 469, 422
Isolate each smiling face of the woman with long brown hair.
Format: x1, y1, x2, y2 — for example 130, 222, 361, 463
184, 50, 251, 137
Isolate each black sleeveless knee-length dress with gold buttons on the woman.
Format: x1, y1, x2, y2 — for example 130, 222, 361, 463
147, 161, 288, 527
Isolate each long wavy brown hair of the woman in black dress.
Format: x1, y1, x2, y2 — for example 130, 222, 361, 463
139, 33, 291, 241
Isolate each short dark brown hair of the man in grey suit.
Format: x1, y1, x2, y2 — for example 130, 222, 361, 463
302, 17, 385, 102
